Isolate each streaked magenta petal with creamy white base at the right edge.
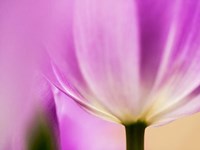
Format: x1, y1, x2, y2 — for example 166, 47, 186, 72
139, 0, 200, 123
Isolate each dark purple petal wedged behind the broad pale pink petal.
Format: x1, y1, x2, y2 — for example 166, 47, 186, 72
136, 0, 178, 89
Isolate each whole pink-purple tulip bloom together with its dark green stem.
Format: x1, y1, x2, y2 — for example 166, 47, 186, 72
45, 0, 200, 150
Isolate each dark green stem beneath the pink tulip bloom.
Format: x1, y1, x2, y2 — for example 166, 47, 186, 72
125, 122, 147, 150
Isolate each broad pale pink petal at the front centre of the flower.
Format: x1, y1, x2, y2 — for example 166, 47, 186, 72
73, 0, 140, 122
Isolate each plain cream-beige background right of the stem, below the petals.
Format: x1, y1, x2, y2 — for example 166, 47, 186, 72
145, 113, 200, 150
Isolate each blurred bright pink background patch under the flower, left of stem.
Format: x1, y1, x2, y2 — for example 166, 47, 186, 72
55, 89, 125, 150
